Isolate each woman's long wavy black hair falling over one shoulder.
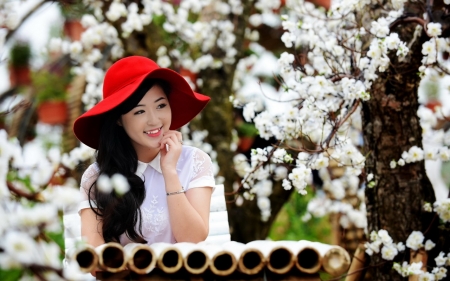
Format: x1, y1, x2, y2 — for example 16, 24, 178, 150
88, 79, 169, 242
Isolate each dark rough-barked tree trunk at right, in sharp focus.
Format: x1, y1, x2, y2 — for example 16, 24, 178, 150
362, 2, 437, 280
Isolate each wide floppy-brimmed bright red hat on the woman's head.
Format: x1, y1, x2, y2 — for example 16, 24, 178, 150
73, 56, 210, 149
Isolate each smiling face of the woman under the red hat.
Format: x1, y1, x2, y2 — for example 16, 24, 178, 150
119, 85, 172, 162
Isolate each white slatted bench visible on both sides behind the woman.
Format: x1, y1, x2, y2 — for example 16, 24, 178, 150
63, 184, 231, 254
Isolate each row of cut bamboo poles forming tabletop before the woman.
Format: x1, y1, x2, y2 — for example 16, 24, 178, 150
71, 237, 350, 280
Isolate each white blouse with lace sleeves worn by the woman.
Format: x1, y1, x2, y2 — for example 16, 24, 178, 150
78, 146, 215, 245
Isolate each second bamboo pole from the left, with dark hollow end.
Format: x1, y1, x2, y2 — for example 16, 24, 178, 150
95, 242, 126, 273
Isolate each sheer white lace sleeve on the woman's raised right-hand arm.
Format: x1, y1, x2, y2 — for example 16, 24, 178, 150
187, 149, 215, 189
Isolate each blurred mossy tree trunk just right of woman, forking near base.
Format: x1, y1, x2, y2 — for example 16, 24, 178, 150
200, 1, 291, 243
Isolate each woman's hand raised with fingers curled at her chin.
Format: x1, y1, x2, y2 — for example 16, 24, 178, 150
159, 131, 182, 172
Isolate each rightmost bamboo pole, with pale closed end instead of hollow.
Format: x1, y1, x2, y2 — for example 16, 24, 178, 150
311, 242, 350, 276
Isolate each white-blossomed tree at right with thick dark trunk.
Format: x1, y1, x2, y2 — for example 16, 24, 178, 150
236, 1, 449, 280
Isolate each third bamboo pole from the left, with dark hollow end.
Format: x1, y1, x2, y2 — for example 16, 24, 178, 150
123, 243, 156, 274
